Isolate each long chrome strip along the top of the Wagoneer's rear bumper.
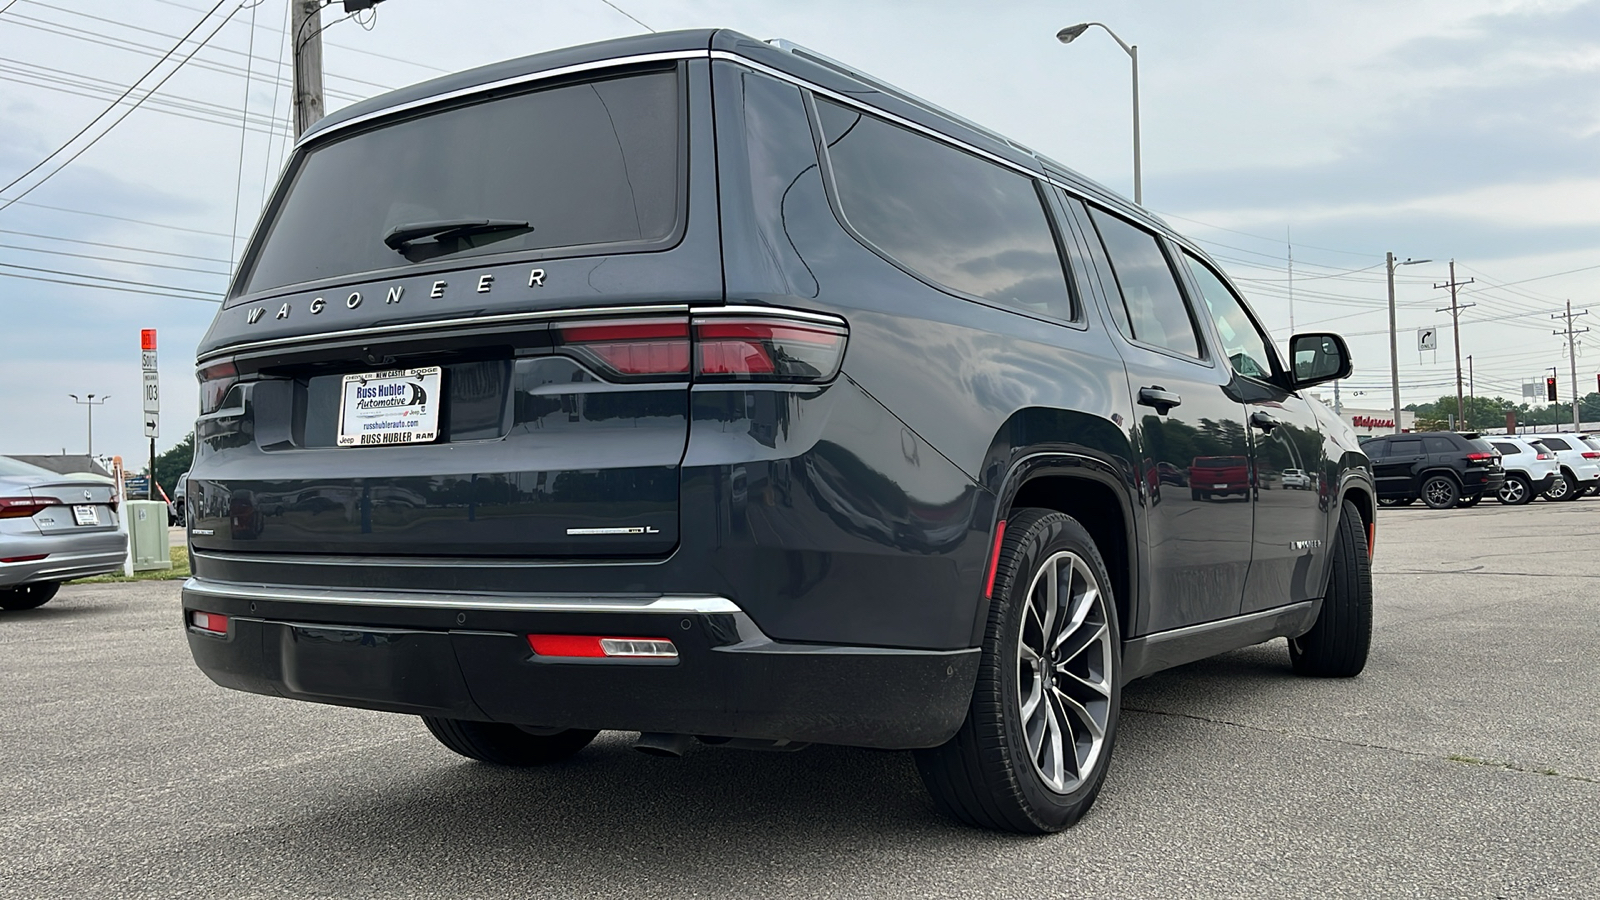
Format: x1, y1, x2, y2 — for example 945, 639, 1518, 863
182, 578, 741, 615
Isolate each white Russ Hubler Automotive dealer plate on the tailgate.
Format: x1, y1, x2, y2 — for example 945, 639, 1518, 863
339, 365, 443, 447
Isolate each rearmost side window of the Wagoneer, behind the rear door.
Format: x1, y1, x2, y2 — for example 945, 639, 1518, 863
816, 99, 1077, 320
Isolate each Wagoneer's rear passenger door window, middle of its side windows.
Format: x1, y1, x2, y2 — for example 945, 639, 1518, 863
1090, 208, 1200, 359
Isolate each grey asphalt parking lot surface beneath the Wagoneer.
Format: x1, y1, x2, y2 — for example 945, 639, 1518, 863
0, 500, 1600, 898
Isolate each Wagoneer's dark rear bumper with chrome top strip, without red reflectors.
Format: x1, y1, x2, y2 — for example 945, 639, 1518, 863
182, 578, 979, 749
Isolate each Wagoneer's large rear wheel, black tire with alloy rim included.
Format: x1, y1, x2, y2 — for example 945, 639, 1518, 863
915, 509, 1122, 834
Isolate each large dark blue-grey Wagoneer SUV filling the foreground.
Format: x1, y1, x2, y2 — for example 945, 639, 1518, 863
182, 30, 1374, 831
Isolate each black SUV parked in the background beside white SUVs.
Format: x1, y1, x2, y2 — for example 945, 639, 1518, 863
1362, 431, 1506, 509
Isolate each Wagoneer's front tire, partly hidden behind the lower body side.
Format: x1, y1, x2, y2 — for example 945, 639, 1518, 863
1290, 501, 1373, 677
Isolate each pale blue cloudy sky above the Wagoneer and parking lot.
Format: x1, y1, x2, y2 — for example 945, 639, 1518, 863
0, 0, 1600, 460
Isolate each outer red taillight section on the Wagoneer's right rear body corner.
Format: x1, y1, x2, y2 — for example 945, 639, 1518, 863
694, 317, 846, 384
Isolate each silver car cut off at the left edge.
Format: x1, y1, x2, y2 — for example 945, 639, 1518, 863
0, 456, 128, 610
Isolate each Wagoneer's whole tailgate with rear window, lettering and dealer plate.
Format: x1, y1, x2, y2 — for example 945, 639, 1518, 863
187, 61, 723, 557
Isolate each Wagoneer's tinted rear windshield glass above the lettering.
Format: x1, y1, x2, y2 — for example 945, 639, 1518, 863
235, 70, 682, 293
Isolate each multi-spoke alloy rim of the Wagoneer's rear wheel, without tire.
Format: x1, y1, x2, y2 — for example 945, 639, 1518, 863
1016, 551, 1114, 794
